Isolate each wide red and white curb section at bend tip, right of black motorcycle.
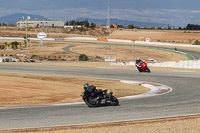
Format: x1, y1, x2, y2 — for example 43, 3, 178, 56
118, 81, 173, 100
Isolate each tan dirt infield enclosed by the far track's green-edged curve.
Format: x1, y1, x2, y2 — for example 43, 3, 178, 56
71, 44, 188, 62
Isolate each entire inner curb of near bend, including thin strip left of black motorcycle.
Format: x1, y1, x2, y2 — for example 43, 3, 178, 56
0, 81, 172, 109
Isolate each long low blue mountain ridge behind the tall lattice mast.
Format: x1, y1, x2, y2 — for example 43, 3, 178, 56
76, 18, 168, 28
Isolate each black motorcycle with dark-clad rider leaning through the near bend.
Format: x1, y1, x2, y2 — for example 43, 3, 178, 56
81, 87, 119, 107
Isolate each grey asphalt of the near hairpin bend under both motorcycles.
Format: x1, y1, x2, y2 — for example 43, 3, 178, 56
0, 64, 200, 130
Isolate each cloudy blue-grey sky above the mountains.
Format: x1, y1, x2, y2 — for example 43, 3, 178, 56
0, 0, 200, 27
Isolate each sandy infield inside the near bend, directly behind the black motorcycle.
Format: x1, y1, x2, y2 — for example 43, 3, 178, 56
0, 74, 149, 107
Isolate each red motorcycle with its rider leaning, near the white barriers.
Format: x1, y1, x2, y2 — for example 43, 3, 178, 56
135, 59, 151, 73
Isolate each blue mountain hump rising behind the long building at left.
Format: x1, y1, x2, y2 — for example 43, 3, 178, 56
0, 13, 49, 24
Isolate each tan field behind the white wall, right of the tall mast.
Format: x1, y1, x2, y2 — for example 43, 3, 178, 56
108, 30, 200, 44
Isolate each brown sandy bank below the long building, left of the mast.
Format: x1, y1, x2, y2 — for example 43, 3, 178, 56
0, 27, 105, 38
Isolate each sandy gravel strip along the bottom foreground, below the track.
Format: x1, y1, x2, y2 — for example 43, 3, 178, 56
4, 116, 200, 133
